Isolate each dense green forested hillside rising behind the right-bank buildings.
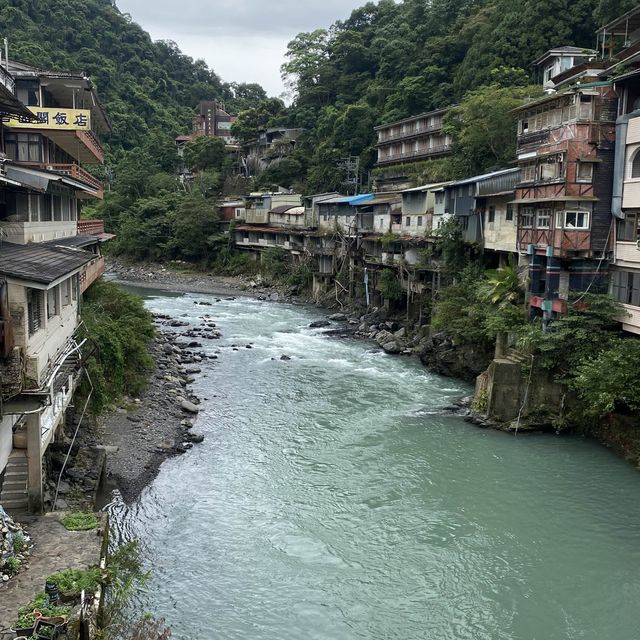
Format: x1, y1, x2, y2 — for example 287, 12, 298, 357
262, 0, 636, 191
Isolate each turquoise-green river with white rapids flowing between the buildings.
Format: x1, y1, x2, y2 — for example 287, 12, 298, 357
113, 293, 640, 640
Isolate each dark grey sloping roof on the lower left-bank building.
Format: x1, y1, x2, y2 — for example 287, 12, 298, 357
0, 242, 95, 284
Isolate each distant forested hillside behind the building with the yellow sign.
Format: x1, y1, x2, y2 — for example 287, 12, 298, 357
0, 0, 266, 150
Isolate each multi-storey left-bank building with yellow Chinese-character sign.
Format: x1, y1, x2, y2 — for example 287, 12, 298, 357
0, 57, 110, 511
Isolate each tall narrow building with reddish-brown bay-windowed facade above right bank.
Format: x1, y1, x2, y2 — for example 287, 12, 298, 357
513, 48, 617, 319
